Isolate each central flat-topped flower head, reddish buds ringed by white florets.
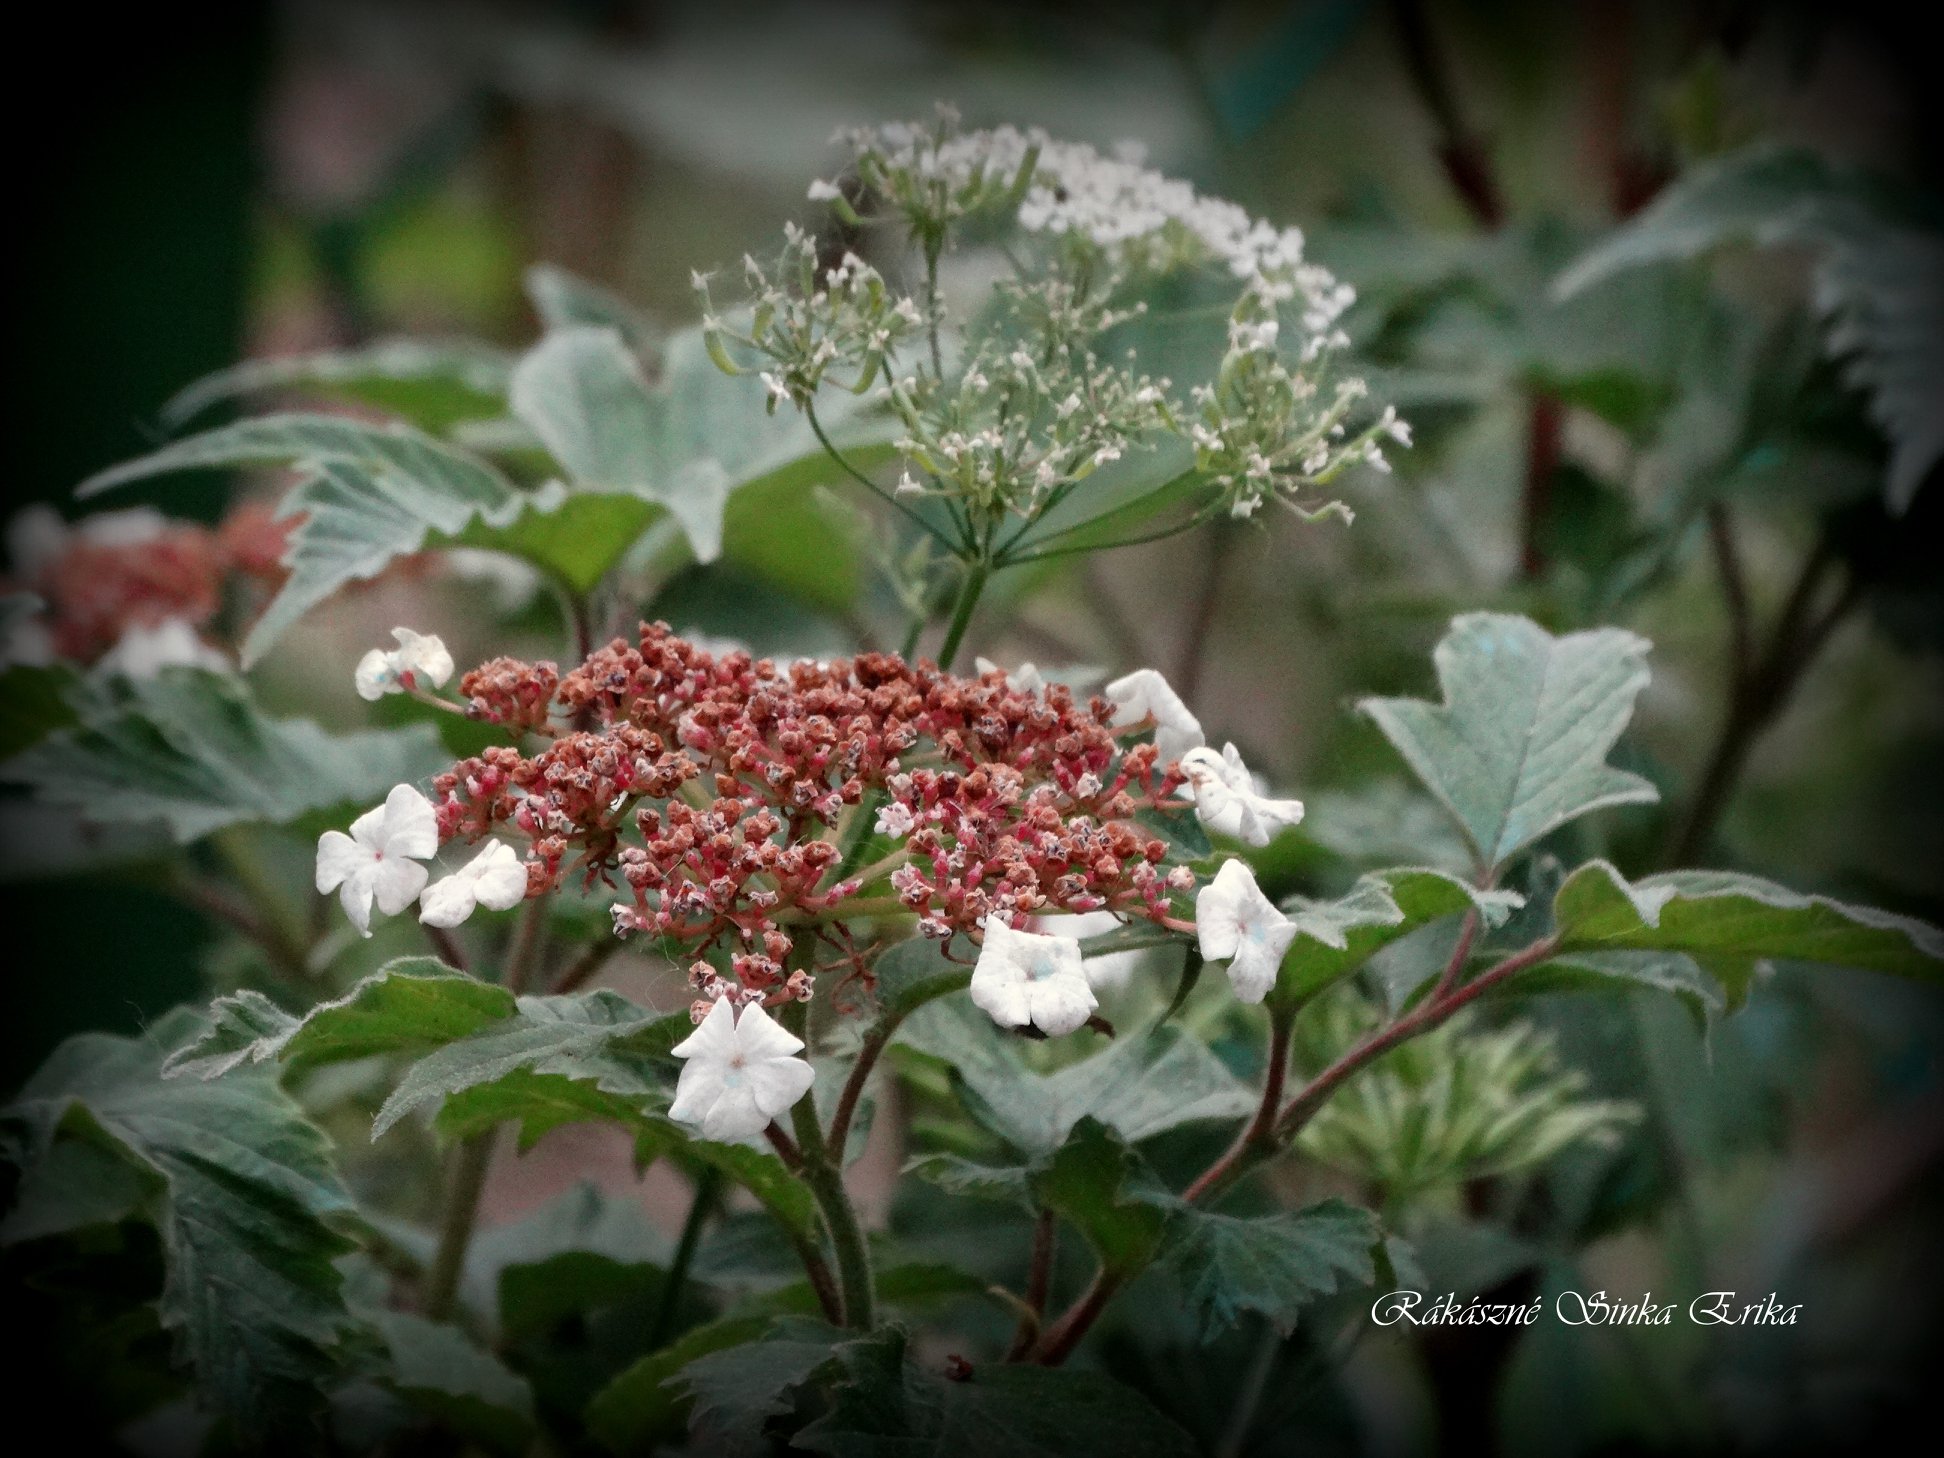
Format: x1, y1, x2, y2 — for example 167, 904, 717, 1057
317, 624, 1302, 1137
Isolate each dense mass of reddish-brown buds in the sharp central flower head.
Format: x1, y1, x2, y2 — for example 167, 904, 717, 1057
434, 624, 1194, 1003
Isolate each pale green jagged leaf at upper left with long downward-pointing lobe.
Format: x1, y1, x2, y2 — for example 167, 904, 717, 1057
80, 414, 529, 667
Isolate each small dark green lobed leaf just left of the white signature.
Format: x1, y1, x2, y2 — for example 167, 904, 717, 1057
1161, 1199, 1382, 1341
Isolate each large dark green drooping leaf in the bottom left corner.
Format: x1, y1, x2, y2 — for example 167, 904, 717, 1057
6, 1013, 352, 1433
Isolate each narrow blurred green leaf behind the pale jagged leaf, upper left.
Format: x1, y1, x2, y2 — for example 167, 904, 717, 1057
161, 338, 513, 432
